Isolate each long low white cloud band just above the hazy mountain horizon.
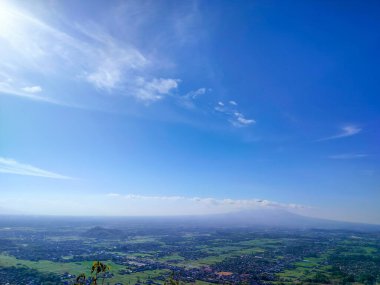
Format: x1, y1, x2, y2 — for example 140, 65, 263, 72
0, 191, 312, 216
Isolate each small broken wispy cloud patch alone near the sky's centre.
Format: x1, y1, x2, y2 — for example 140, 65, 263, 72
214, 101, 256, 128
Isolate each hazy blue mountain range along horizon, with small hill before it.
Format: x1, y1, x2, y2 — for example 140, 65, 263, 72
0, 208, 380, 231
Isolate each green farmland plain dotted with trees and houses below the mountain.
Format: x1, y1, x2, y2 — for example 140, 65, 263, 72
0, 216, 380, 285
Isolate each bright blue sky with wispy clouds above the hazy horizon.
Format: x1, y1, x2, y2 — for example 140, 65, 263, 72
0, 1, 380, 223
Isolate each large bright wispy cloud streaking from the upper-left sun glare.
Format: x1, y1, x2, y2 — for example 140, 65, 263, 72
0, 1, 184, 101
